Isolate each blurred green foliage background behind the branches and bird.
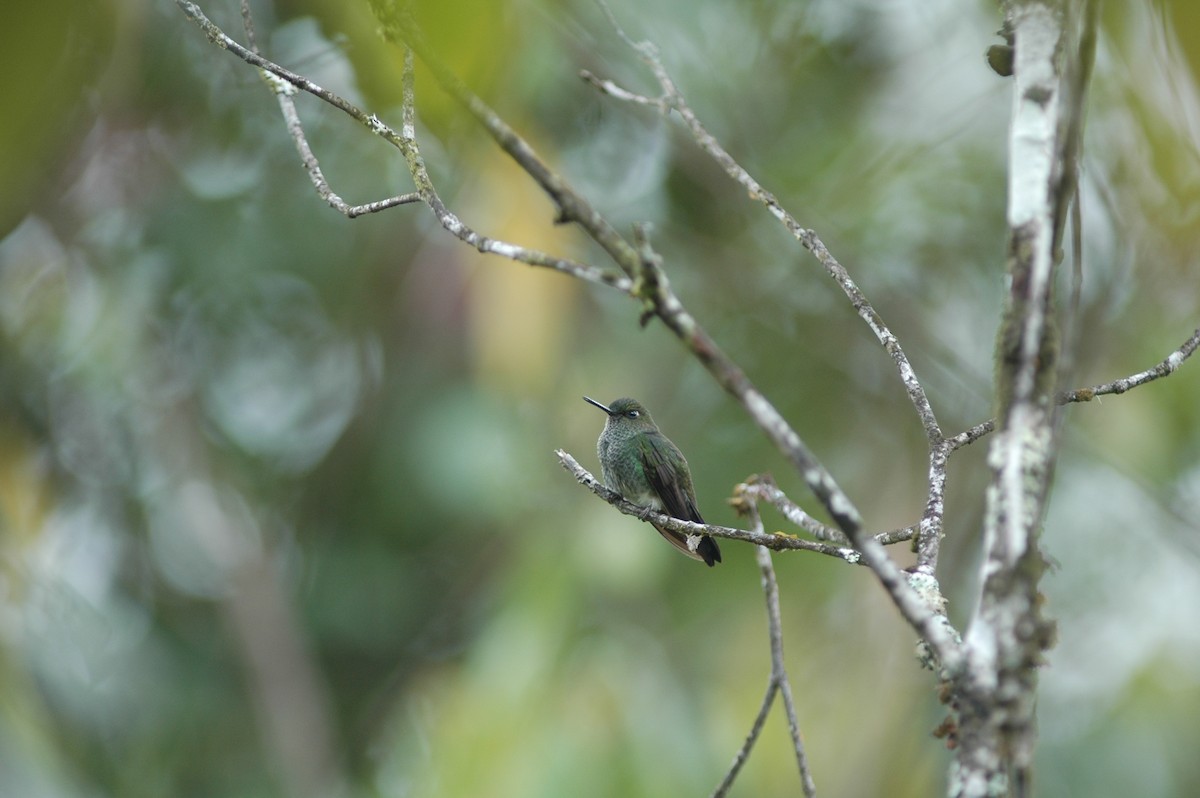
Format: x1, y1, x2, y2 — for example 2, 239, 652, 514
0, 0, 1200, 798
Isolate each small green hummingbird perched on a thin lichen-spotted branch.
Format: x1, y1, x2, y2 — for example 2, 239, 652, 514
583, 396, 721, 568
